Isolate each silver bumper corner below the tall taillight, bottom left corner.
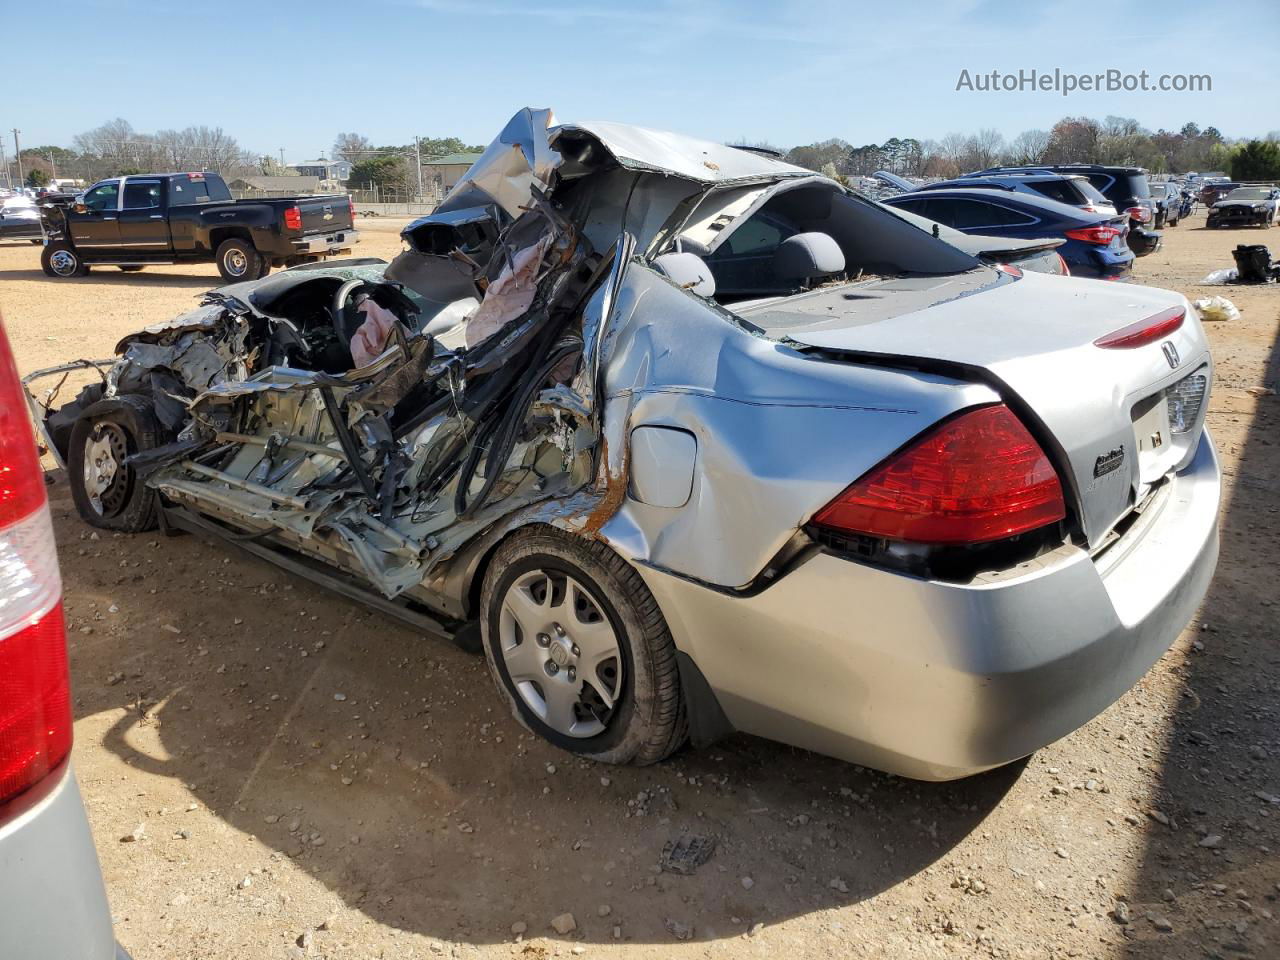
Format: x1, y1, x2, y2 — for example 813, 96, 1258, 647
0, 764, 120, 960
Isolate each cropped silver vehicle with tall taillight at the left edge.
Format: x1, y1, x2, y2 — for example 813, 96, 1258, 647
0, 323, 128, 960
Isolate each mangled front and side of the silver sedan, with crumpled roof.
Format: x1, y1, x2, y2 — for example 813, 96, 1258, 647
24, 109, 839, 616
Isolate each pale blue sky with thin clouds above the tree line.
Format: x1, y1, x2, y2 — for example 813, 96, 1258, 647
10, 0, 1280, 161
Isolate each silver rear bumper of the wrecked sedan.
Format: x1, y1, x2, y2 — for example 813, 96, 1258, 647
639, 433, 1221, 780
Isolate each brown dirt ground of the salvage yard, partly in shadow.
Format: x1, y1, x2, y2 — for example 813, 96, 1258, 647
0, 216, 1280, 960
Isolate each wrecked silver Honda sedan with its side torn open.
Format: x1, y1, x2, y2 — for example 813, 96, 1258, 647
28, 110, 1220, 780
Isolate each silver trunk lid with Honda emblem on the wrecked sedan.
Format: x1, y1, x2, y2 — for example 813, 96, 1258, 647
736, 270, 1212, 545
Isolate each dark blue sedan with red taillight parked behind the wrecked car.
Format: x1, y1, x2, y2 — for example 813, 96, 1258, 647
883, 187, 1134, 280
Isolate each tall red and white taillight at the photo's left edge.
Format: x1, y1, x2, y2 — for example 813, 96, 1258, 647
0, 321, 72, 804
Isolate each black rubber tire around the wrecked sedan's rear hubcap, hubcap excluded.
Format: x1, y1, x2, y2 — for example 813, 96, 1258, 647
480, 526, 689, 765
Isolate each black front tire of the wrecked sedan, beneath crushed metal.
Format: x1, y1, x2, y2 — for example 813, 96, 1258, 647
67, 394, 165, 534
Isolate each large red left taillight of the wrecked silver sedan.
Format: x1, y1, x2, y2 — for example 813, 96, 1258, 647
813, 404, 1066, 544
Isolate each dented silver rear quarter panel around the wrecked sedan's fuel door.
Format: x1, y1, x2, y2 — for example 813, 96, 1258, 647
588, 262, 997, 588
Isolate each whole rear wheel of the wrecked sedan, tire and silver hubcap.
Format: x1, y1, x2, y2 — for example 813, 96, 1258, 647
480, 527, 687, 764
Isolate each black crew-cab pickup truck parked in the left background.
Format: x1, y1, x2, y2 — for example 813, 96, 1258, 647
40, 173, 358, 283
